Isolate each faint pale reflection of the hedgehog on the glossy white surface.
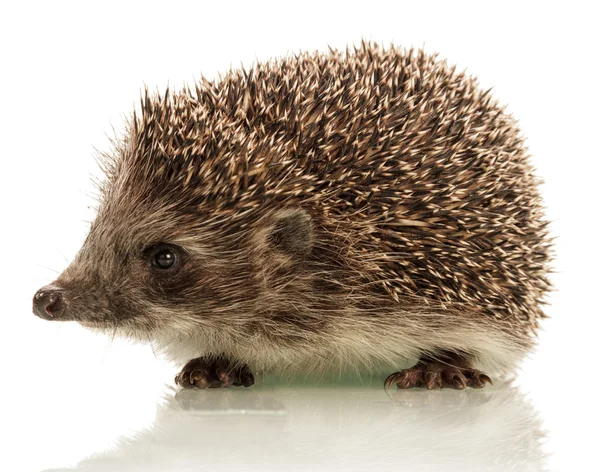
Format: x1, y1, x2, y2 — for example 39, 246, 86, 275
43, 384, 545, 471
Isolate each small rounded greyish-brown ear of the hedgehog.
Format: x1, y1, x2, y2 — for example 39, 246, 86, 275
267, 208, 313, 257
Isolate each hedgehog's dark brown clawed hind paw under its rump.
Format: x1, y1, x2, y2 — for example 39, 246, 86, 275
384, 351, 492, 390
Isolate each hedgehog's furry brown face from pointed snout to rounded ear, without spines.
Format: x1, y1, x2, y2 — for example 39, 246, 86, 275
34, 197, 312, 339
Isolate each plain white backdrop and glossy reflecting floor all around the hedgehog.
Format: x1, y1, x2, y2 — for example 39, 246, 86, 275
0, 1, 600, 471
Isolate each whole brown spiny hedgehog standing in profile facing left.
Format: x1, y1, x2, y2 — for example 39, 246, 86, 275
33, 42, 552, 389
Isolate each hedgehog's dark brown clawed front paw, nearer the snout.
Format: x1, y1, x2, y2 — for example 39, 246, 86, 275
175, 354, 254, 388
